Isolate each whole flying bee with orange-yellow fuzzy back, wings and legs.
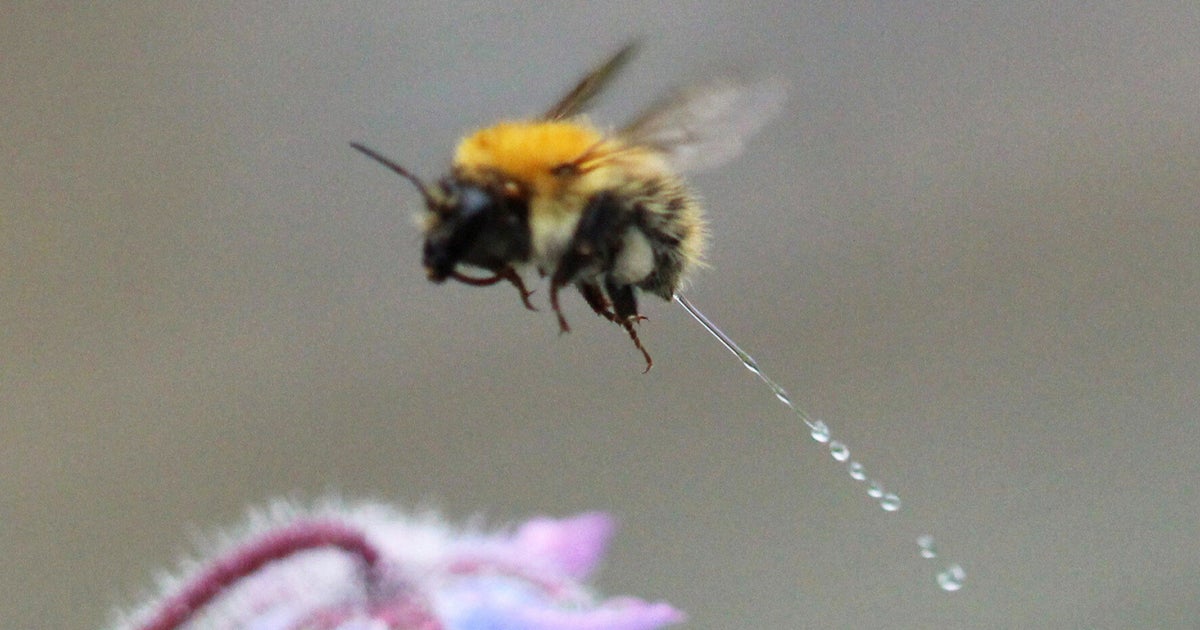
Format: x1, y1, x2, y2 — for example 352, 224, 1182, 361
352, 44, 784, 371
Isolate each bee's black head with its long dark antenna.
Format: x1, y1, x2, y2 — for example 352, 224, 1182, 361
350, 143, 530, 282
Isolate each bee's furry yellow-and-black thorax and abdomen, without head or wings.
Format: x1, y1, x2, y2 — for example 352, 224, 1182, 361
451, 120, 706, 300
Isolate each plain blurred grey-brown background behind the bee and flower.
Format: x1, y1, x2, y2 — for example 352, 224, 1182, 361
0, 1, 1200, 629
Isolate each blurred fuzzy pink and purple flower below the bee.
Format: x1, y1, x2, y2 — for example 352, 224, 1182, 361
113, 504, 683, 630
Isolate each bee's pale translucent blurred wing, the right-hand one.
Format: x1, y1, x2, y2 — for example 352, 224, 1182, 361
618, 78, 787, 170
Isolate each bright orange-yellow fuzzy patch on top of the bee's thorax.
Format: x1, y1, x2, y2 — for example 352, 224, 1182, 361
454, 120, 610, 194
